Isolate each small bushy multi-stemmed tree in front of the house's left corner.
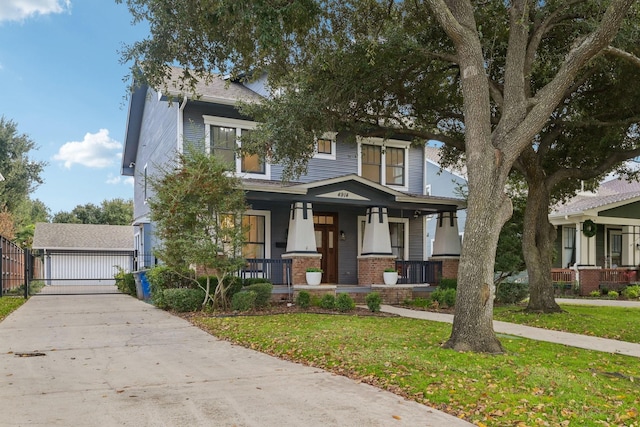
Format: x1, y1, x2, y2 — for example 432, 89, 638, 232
148, 145, 247, 308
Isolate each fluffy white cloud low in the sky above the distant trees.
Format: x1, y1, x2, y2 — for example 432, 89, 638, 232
53, 129, 122, 169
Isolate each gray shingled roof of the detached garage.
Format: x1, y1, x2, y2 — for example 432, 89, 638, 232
33, 222, 134, 251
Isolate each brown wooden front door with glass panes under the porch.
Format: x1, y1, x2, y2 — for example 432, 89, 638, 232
313, 213, 338, 283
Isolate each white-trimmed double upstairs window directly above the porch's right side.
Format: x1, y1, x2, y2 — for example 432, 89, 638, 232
358, 140, 409, 189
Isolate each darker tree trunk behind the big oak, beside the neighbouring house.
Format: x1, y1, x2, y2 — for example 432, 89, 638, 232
522, 177, 562, 313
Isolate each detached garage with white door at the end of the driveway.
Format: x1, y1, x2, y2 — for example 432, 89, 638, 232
32, 223, 135, 286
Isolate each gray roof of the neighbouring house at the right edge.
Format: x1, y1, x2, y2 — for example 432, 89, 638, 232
549, 178, 640, 217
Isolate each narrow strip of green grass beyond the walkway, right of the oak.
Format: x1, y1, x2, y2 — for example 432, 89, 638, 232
493, 304, 640, 343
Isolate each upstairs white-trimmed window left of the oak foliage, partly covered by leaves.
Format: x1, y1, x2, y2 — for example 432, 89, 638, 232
204, 116, 271, 179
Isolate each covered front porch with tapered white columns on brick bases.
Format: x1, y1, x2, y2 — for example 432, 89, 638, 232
239, 175, 464, 286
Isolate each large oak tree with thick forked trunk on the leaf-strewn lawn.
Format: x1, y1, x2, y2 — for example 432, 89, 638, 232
123, 0, 638, 352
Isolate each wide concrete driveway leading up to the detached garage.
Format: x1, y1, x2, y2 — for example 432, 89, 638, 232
0, 295, 470, 427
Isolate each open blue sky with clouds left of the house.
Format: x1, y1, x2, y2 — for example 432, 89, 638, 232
0, 0, 147, 214
